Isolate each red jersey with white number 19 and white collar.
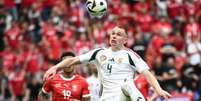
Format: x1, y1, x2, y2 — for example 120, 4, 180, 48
42, 74, 89, 101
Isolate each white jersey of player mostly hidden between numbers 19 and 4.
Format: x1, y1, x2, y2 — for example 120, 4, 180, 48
87, 75, 101, 101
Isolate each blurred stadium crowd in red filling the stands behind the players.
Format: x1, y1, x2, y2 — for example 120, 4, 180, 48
0, 0, 201, 101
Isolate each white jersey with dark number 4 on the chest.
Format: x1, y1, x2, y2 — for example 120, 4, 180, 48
79, 48, 149, 99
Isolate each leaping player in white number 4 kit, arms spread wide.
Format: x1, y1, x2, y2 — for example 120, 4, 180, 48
44, 27, 171, 101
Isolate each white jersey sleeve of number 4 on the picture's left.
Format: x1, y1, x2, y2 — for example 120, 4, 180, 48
79, 48, 102, 63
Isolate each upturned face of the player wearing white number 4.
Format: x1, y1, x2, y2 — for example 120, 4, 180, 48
110, 27, 127, 47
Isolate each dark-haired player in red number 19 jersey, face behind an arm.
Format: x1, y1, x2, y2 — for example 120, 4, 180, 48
39, 52, 90, 101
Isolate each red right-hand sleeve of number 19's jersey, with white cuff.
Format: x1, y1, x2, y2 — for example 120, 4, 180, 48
82, 80, 90, 97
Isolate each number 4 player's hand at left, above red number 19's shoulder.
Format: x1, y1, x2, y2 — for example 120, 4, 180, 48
43, 67, 57, 81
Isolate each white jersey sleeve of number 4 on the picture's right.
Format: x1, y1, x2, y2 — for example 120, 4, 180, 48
128, 52, 149, 73
